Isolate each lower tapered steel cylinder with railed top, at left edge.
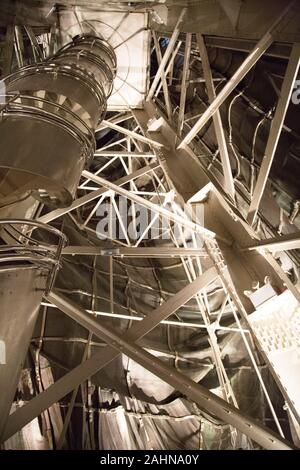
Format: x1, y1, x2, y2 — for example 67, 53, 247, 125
0, 219, 66, 442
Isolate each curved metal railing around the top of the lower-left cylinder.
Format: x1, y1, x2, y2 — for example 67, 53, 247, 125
0, 219, 68, 292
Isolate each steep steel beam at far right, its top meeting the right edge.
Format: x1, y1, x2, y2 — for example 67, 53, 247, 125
247, 44, 300, 225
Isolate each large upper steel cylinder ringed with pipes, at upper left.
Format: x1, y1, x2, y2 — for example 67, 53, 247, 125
0, 35, 116, 206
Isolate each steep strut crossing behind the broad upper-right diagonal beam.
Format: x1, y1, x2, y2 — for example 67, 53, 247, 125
197, 34, 235, 200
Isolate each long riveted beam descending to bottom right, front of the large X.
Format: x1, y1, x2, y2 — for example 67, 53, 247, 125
19, 290, 292, 450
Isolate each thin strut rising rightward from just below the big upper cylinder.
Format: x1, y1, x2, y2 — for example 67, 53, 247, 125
38, 163, 159, 224
